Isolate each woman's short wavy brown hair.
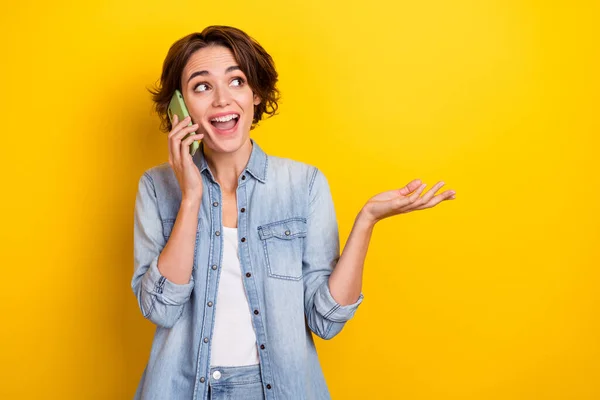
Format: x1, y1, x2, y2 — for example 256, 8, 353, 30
148, 25, 280, 132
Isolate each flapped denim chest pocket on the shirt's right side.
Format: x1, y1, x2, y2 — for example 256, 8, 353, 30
258, 218, 306, 281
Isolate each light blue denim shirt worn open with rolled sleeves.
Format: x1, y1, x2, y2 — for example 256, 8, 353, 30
131, 139, 363, 400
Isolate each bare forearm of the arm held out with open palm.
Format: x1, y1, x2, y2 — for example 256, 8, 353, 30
329, 211, 375, 306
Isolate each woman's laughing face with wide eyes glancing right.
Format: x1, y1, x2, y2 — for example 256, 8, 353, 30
181, 46, 260, 153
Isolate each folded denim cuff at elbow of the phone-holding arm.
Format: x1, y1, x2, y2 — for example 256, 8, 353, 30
142, 256, 194, 306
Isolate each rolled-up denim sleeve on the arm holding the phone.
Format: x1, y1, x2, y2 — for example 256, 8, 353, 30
131, 172, 194, 328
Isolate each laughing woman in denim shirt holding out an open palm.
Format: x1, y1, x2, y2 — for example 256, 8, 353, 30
132, 26, 453, 400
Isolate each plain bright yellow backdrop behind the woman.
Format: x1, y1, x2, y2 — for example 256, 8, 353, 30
0, 0, 600, 400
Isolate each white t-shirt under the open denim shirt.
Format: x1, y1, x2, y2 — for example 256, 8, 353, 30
210, 226, 259, 367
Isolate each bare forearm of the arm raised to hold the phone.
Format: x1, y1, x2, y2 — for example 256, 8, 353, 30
158, 199, 200, 285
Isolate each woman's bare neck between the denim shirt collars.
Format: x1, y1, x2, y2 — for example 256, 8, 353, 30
203, 138, 252, 193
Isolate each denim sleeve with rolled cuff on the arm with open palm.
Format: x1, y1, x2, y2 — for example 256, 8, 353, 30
302, 168, 364, 339
